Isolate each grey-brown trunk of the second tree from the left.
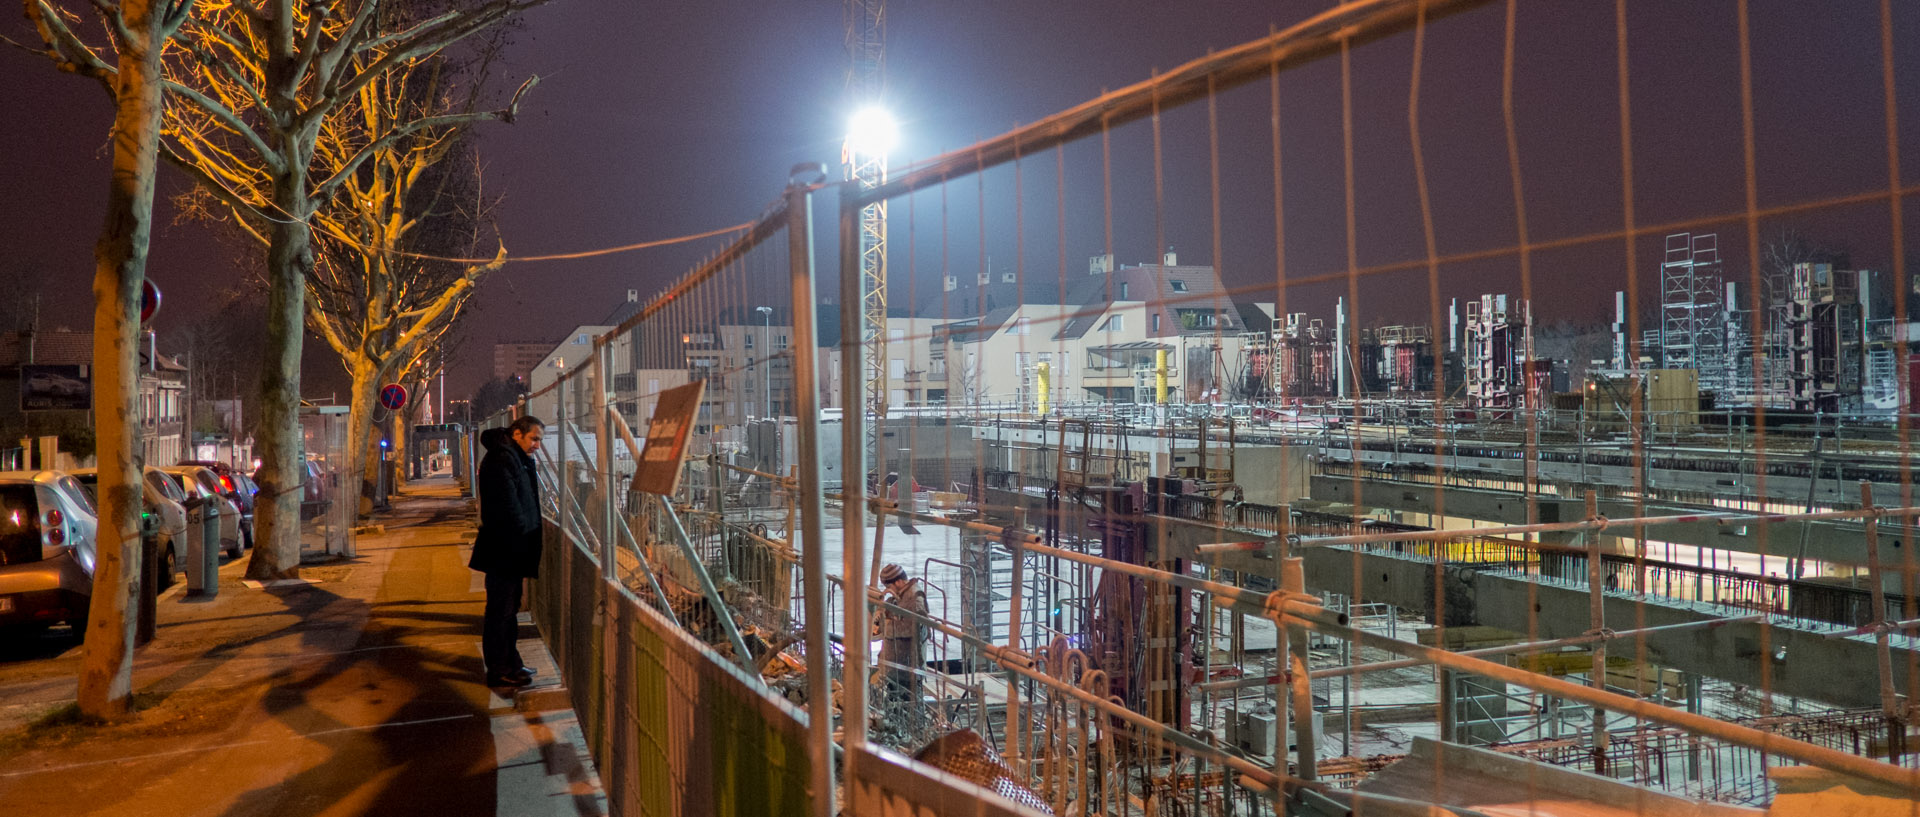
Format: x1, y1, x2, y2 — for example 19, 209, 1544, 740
246, 161, 316, 581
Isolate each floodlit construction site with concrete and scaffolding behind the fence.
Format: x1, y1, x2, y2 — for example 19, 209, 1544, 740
468, 2, 1920, 817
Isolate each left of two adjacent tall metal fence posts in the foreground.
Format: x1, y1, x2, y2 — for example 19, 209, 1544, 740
787, 165, 837, 817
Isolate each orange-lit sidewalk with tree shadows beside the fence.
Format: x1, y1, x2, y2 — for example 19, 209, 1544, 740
0, 479, 605, 817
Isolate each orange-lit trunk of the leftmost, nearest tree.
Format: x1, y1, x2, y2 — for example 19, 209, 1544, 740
79, 0, 165, 719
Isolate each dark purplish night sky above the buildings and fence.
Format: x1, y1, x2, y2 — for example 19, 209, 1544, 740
0, 0, 1920, 395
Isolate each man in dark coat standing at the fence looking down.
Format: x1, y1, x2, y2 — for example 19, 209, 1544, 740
467, 416, 545, 687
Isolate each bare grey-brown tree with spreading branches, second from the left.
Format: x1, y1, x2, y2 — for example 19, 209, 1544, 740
29, 0, 545, 579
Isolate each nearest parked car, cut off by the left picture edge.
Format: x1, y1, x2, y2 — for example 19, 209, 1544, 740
0, 470, 98, 635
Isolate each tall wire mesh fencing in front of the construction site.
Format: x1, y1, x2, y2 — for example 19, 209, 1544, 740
528, 0, 1920, 815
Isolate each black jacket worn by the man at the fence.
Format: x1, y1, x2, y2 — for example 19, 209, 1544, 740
467, 428, 540, 577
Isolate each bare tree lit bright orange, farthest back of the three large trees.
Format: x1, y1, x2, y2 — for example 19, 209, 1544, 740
196, 0, 518, 525
